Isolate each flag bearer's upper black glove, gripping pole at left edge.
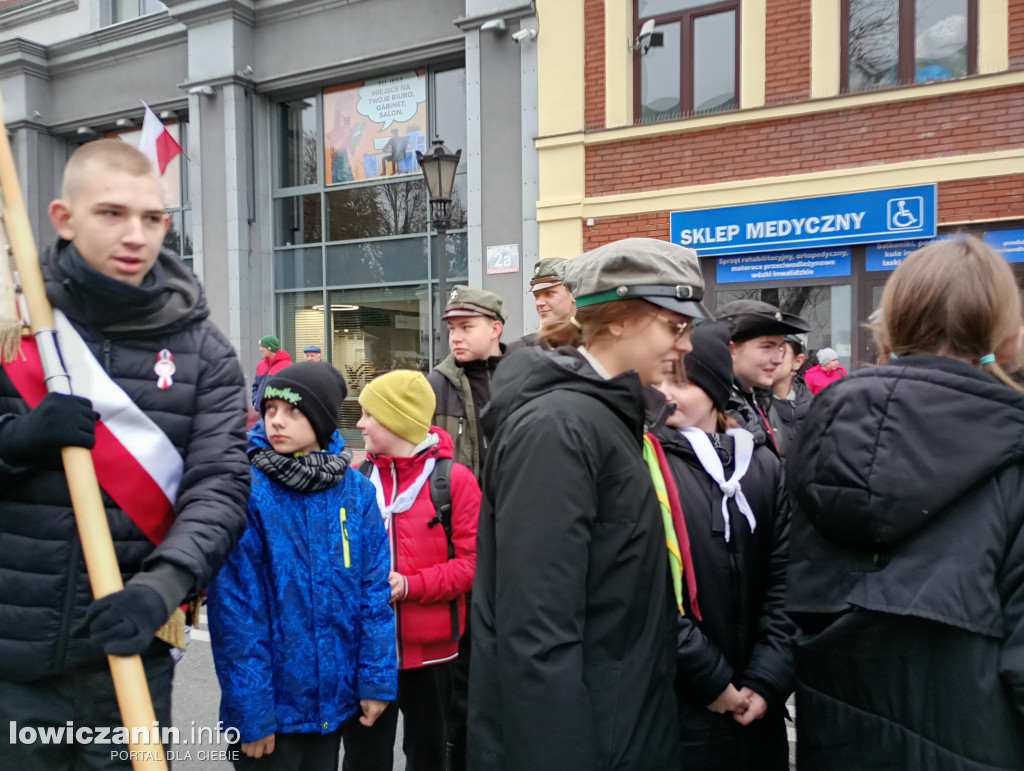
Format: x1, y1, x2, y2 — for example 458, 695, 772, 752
0, 393, 96, 466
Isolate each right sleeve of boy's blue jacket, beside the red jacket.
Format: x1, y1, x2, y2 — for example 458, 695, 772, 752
352, 481, 398, 701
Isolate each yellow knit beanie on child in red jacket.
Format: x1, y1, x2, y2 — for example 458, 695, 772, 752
359, 370, 436, 444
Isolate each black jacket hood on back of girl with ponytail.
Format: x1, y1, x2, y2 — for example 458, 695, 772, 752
786, 354, 1024, 549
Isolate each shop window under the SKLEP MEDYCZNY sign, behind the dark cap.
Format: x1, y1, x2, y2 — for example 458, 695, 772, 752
715, 284, 853, 370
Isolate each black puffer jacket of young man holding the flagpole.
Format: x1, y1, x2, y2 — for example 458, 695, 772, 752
0, 241, 249, 680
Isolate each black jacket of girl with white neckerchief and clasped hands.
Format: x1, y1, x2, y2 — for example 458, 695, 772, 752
654, 411, 795, 769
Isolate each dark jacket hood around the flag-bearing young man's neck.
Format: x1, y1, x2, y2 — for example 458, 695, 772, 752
39, 239, 210, 334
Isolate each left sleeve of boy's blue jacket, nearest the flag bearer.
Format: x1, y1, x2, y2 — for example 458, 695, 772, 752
207, 501, 278, 741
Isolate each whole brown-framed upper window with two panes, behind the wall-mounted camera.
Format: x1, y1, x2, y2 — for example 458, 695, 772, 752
634, 0, 739, 122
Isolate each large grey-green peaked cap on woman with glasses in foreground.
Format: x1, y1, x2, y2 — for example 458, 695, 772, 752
562, 239, 711, 318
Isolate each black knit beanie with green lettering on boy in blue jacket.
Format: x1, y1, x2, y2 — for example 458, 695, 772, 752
259, 361, 348, 449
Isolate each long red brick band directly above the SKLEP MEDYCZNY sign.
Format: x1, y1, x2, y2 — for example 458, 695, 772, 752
586, 87, 1024, 197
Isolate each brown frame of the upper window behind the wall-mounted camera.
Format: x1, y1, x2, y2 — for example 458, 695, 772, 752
633, 0, 741, 123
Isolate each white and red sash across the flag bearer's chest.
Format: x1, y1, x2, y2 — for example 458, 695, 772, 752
3, 310, 184, 544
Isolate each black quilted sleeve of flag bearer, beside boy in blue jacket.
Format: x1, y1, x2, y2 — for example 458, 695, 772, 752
142, 323, 249, 602
